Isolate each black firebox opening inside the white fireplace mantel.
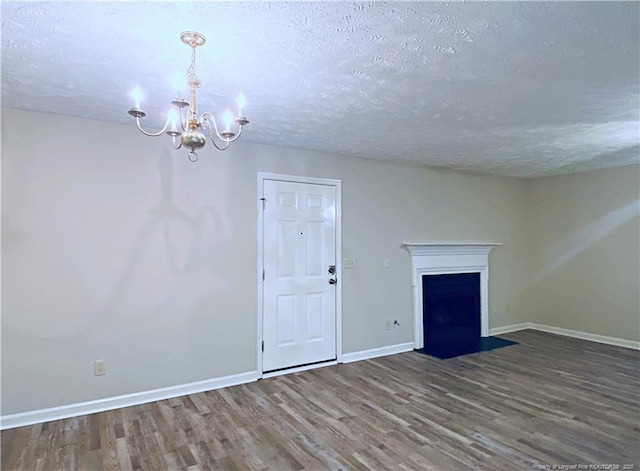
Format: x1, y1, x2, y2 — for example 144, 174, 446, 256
422, 273, 480, 358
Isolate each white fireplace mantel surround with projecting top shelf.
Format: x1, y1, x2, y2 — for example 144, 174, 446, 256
402, 242, 502, 348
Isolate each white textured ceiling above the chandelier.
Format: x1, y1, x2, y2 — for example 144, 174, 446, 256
1, 1, 640, 177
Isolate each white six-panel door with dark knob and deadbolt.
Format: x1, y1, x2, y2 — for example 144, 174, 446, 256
262, 180, 336, 371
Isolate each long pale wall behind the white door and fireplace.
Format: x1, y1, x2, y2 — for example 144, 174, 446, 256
2, 109, 528, 415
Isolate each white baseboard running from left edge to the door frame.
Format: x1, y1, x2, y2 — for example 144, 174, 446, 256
0, 371, 259, 430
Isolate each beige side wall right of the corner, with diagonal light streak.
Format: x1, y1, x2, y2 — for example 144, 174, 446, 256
523, 165, 640, 341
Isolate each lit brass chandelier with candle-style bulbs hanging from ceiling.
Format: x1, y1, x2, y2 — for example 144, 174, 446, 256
129, 31, 249, 162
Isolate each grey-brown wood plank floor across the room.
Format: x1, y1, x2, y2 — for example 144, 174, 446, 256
1, 331, 640, 471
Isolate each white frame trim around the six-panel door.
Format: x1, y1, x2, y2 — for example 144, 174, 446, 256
256, 172, 342, 378
